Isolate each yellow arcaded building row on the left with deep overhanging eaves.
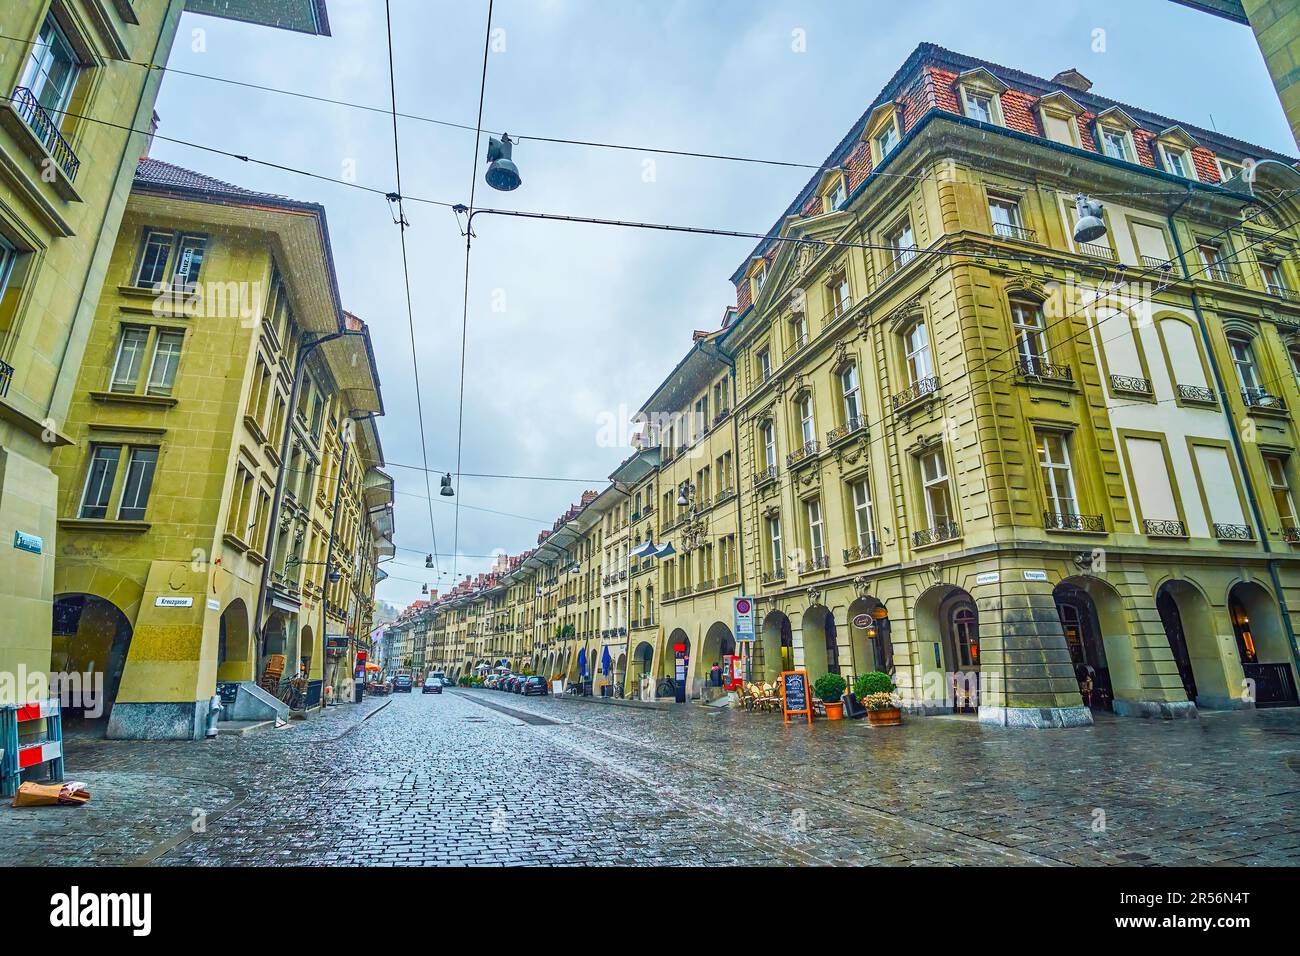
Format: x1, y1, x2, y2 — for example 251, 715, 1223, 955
52, 159, 393, 739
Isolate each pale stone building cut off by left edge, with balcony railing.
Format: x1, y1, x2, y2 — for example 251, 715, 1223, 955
0, 0, 329, 700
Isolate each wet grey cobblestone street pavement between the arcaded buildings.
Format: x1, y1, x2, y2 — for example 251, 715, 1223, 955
0, 691, 1300, 866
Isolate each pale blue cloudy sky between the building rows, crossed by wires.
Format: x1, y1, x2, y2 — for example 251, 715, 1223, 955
153, 0, 1295, 605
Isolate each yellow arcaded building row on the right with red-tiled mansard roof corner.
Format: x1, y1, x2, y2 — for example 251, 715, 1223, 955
428, 44, 1300, 727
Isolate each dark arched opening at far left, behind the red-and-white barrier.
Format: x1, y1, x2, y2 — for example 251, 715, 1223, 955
51, 593, 134, 719
